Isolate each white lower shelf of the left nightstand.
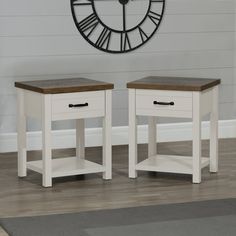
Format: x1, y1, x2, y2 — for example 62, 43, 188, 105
27, 157, 105, 178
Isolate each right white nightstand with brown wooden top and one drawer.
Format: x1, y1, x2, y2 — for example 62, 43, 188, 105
127, 77, 220, 183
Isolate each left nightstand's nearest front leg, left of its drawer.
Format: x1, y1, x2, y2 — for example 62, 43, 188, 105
42, 95, 52, 187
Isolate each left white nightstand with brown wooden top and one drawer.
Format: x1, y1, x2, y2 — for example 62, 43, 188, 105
15, 78, 114, 187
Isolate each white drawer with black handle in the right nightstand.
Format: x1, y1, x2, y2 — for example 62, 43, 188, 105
136, 89, 192, 118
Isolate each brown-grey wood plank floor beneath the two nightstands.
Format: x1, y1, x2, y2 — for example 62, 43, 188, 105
0, 139, 236, 220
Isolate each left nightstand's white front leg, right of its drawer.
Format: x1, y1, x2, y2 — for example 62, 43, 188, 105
103, 90, 112, 179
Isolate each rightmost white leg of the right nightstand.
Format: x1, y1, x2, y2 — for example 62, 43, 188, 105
210, 86, 218, 172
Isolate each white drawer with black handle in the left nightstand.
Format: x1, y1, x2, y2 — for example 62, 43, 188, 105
52, 91, 105, 120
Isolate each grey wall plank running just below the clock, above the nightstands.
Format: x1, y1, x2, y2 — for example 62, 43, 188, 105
0, 50, 233, 77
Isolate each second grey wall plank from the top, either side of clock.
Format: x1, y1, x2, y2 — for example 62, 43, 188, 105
0, 14, 234, 37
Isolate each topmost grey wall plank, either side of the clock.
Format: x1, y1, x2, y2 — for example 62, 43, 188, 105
0, 0, 234, 16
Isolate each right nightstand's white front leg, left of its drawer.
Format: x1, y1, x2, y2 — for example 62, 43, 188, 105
129, 89, 137, 178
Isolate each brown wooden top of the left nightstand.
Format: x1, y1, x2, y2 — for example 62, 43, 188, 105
15, 78, 114, 94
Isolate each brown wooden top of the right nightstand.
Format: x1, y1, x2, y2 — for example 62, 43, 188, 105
127, 76, 220, 91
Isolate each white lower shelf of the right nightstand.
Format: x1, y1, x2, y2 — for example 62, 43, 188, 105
136, 155, 210, 174
